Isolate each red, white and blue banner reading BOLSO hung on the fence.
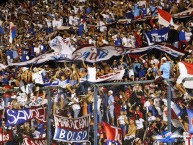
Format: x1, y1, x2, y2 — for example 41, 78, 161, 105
54, 115, 90, 142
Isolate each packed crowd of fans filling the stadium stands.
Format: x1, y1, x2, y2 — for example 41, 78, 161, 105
0, 0, 193, 145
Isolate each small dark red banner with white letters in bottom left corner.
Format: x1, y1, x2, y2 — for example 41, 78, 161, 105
0, 128, 13, 143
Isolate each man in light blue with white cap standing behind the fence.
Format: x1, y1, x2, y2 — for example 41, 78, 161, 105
107, 90, 115, 125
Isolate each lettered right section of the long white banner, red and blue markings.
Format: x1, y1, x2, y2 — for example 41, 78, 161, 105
72, 44, 184, 62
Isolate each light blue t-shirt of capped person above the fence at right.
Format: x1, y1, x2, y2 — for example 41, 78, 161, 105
160, 61, 171, 79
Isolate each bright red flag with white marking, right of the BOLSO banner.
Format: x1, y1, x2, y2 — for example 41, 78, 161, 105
102, 122, 122, 141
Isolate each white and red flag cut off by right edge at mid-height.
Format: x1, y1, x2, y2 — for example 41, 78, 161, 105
178, 62, 193, 89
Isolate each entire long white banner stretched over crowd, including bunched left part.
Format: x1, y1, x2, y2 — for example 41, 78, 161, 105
0, 40, 184, 67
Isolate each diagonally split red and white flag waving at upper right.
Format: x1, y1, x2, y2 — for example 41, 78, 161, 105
158, 8, 178, 29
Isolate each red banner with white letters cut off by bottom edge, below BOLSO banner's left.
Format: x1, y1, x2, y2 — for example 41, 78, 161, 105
22, 137, 47, 145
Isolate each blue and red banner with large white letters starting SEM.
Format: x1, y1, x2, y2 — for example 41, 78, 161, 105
5, 107, 45, 126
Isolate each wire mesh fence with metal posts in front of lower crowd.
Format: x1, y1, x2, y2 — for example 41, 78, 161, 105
1, 80, 191, 145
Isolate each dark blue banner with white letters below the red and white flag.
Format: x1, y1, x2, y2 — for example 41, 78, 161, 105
145, 27, 170, 45
